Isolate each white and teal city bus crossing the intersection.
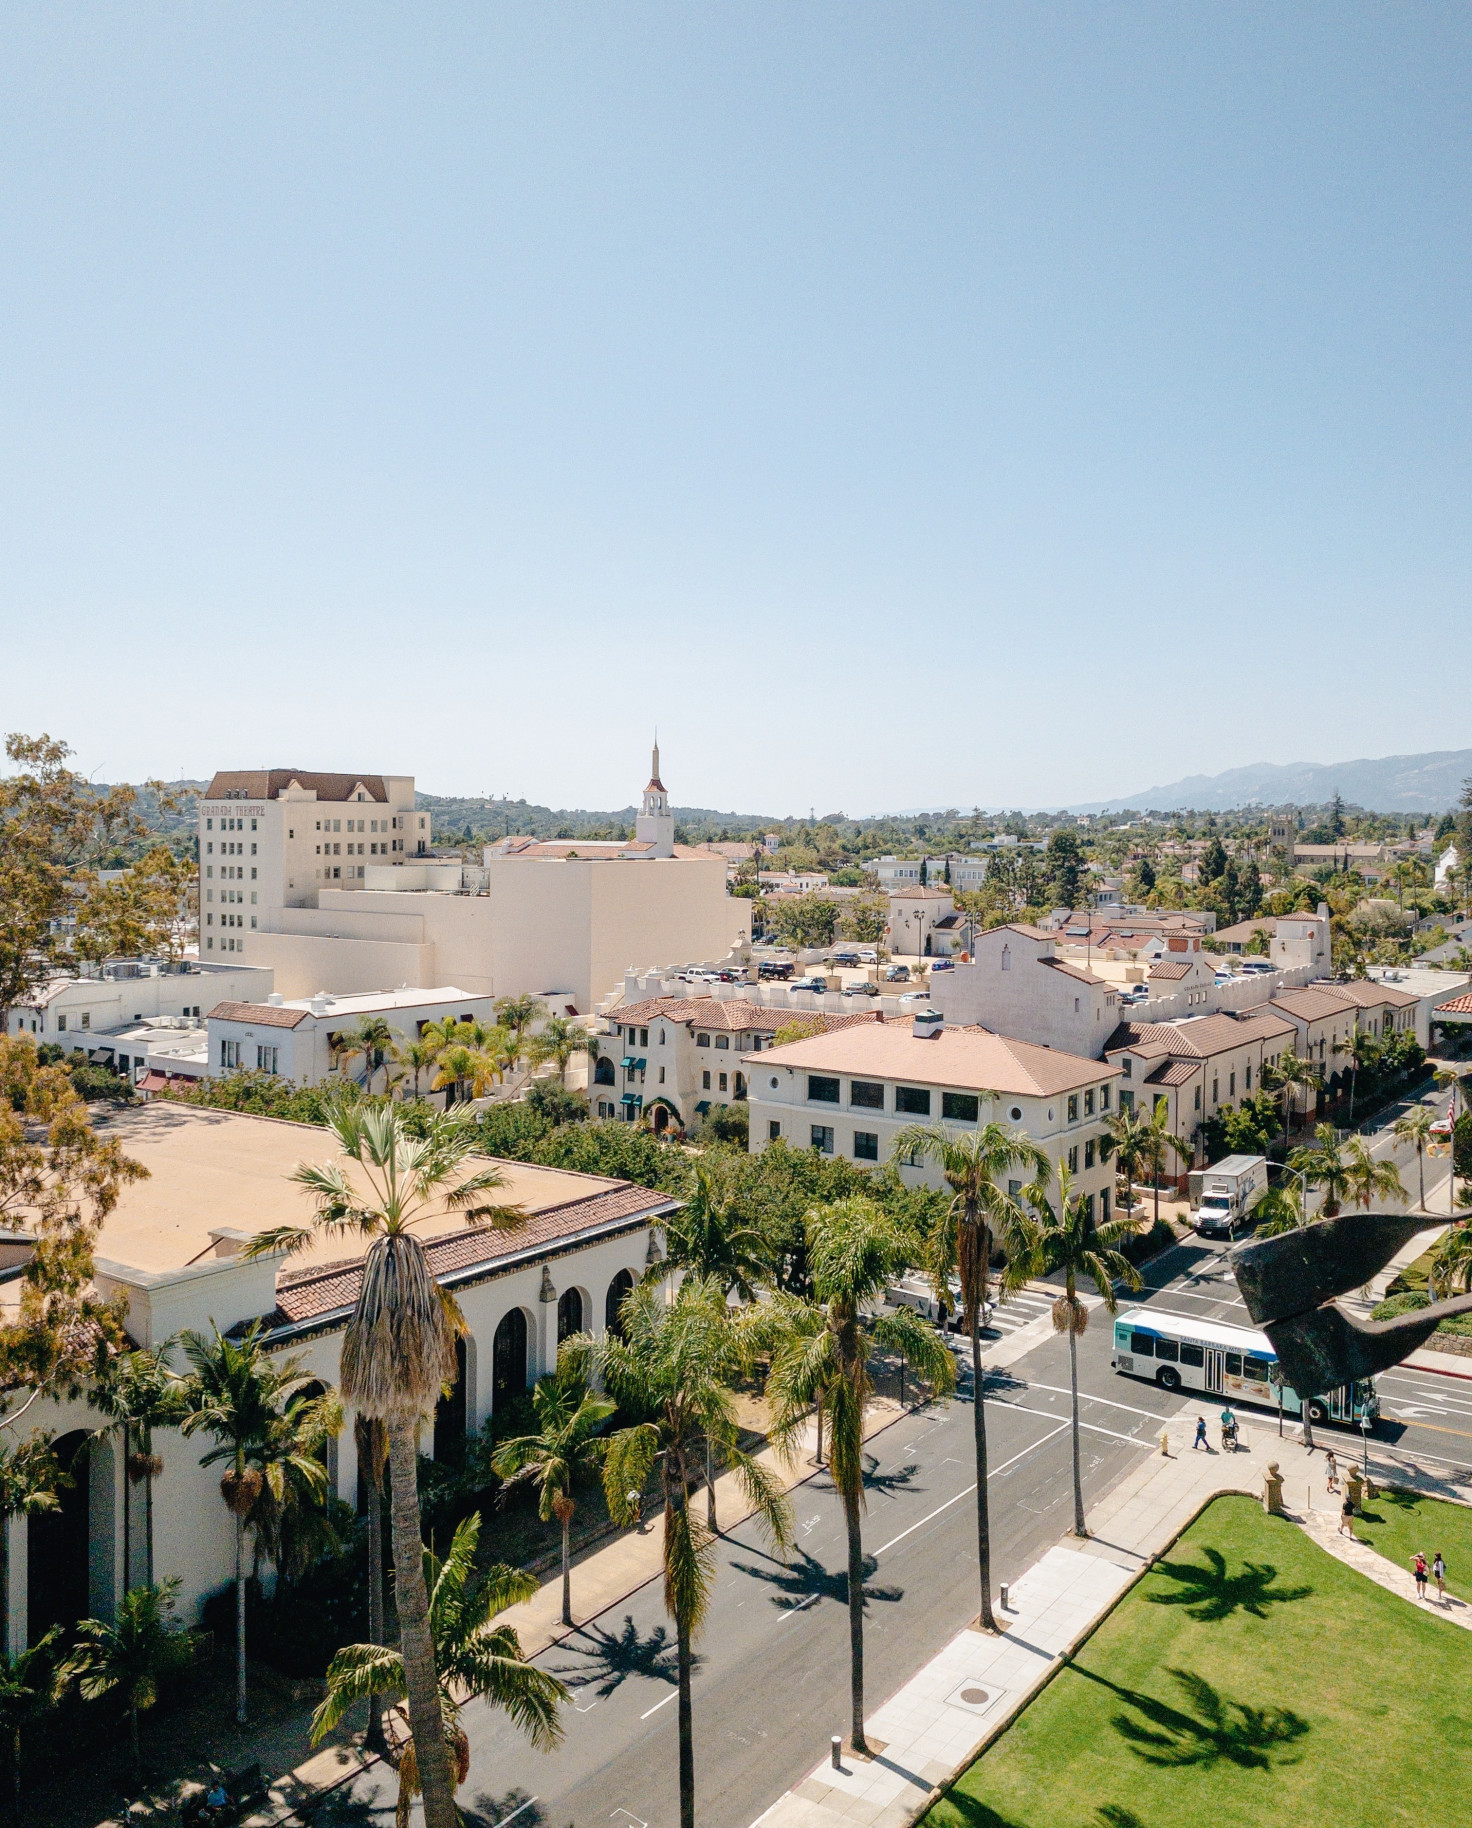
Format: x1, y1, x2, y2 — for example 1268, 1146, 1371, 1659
1110, 1307, 1381, 1428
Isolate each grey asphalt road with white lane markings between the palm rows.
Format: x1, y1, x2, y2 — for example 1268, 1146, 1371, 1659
303, 1082, 1472, 1828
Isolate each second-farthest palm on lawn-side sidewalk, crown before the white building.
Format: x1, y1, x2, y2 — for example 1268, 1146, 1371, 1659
892, 1122, 1053, 1631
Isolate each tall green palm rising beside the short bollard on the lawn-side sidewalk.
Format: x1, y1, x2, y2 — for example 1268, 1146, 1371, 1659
763, 1197, 956, 1751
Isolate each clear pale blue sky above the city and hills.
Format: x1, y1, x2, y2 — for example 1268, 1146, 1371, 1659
0, 0, 1472, 813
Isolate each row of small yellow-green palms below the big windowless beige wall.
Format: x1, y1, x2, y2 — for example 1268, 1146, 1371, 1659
331, 996, 598, 1106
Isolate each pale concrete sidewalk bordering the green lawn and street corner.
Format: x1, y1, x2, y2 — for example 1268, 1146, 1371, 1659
746, 1417, 1472, 1828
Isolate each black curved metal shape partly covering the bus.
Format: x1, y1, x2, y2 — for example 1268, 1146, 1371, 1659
1229, 1212, 1472, 1398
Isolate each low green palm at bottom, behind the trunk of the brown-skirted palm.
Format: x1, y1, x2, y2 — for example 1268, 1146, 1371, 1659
313, 1512, 569, 1828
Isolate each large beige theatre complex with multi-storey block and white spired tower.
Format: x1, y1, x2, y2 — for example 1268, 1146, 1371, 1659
199, 749, 752, 1013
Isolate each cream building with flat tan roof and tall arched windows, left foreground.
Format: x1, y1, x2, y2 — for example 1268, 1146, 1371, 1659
0, 1102, 677, 1654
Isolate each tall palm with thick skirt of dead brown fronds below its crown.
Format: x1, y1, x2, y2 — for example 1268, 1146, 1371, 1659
247, 1106, 525, 1828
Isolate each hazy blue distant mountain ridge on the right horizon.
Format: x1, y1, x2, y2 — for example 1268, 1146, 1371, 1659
1070, 749, 1472, 812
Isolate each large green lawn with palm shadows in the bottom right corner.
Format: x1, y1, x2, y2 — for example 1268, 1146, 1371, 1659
925, 1497, 1472, 1828
